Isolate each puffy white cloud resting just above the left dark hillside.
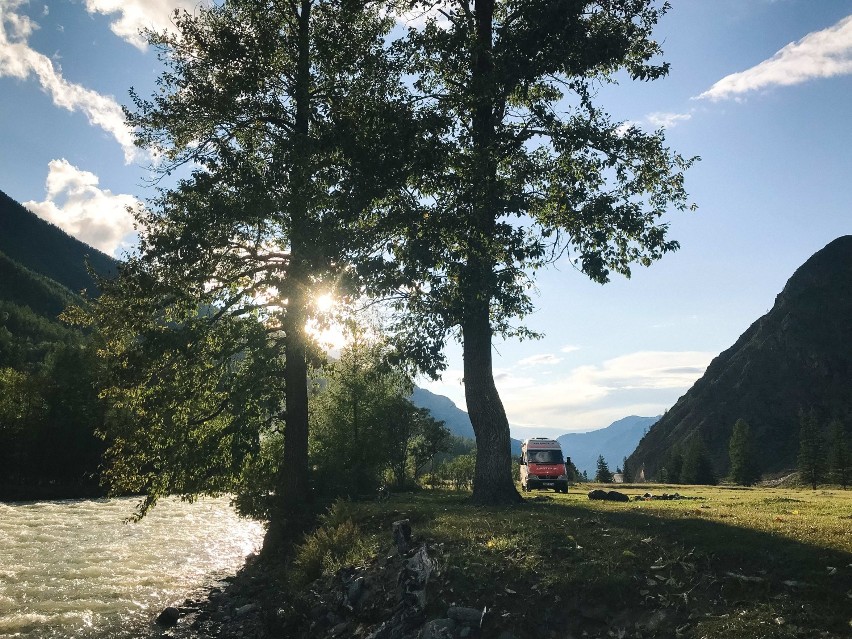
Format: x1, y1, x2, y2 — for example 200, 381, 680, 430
24, 159, 138, 255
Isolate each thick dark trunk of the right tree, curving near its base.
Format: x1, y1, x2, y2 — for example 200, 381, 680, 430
462, 0, 521, 504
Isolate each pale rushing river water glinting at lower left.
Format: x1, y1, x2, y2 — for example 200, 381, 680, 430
0, 499, 263, 639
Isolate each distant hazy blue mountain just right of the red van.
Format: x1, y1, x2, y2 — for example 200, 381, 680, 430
557, 415, 660, 477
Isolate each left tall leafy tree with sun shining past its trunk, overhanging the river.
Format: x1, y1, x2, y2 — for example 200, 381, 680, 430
85, 0, 410, 541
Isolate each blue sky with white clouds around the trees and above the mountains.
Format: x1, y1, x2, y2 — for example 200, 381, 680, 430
0, 0, 852, 438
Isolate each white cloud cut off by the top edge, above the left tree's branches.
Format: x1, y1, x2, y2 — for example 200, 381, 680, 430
86, 0, 206, 51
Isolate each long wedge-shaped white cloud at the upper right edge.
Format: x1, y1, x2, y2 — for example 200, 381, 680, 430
695, 16, 852, 101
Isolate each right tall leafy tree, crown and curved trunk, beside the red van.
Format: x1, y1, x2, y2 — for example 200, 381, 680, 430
391, 0, 692, 504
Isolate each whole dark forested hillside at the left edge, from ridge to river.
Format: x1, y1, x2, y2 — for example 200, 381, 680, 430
0, 193, 110, 499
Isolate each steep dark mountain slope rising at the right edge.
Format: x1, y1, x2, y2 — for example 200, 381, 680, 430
629, 235, 852, 479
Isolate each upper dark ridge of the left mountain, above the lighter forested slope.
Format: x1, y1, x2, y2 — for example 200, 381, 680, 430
0, 186, 118, 293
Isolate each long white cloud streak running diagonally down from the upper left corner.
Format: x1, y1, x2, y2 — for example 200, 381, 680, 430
0, 0, 140, 164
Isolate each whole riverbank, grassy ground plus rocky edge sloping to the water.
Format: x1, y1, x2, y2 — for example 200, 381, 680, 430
153, 485, 852, 639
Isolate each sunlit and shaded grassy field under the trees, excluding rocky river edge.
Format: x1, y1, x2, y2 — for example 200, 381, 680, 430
288, 484, 852, 639
